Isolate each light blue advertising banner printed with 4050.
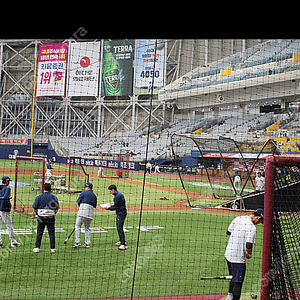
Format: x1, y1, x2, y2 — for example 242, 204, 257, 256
135, 39, 165, 95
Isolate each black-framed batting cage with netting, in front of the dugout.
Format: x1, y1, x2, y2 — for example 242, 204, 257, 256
172, 134, 277, 210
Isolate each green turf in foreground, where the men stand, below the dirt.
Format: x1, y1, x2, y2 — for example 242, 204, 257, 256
0, 210, 262, 299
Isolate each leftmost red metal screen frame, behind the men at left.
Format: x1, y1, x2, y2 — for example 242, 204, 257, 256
13, 155, 46, 217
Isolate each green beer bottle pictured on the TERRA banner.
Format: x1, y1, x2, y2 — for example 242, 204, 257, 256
103, 41, 122, 96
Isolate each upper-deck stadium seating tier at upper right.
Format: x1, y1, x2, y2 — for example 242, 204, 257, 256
160, 40, 300, 94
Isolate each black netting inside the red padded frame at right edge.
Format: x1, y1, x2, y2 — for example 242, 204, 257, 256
269, 165, 300, 299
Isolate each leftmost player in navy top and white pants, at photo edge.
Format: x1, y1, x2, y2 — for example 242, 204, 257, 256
0, 176, 21, 248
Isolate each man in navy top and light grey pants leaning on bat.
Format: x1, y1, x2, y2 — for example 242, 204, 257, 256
73, 182, 97, 248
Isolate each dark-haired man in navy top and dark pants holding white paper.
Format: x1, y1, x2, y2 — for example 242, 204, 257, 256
105, 184, 127, 250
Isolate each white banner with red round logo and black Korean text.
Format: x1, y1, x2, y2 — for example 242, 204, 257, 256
68, 42, 100, 97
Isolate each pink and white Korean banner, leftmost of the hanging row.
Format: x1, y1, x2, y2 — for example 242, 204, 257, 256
36, 43, 68, 97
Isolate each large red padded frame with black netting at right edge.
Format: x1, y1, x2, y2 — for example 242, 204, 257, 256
261, 155, 300, 300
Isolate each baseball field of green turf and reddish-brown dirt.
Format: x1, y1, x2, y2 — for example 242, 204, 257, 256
0, 160, 263, 299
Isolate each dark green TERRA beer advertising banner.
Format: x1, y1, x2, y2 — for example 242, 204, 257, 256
101, 39, 134, 96
